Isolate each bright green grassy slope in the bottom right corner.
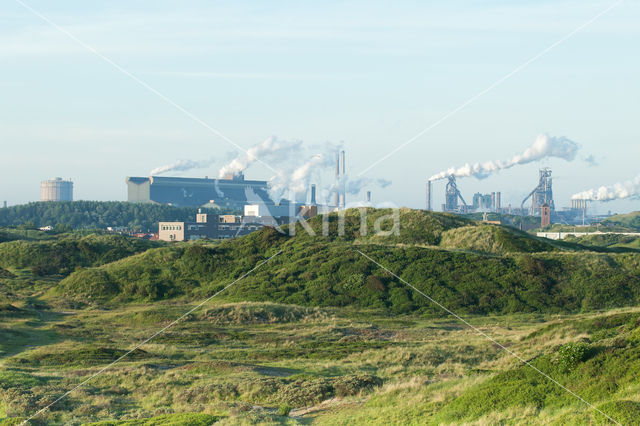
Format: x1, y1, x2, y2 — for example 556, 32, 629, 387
431, 313, 640, 424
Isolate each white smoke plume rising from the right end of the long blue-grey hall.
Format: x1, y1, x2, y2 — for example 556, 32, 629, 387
218, 136, 302, 178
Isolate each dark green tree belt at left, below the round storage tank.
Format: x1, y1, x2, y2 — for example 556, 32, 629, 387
0, 201, 236, 231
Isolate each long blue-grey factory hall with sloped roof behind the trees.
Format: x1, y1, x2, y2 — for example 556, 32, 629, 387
126, 173, 273, 210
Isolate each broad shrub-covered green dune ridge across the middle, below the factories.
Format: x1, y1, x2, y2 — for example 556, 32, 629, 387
51, 210, 640, 313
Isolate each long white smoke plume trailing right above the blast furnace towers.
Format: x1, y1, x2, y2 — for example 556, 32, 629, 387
429, 134, 580, 181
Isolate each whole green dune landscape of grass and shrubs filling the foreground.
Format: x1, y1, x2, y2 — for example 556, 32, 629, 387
0, 209, 640, 425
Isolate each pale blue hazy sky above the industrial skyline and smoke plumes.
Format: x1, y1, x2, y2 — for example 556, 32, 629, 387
0, 0, 640, 213
